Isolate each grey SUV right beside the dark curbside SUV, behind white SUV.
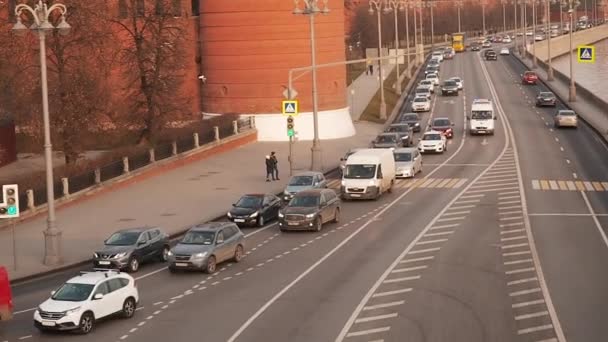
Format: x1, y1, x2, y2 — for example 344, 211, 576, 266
169, 222, 245, 274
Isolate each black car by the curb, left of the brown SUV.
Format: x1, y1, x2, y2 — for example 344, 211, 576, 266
227, 194, 281, 227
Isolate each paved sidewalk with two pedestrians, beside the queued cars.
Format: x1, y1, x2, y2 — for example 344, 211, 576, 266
0, 74, 382, 280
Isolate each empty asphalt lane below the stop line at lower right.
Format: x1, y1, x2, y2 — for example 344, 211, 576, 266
530, 216, 608, 342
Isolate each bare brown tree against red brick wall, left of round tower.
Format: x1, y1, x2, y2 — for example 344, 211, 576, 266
109, 0, 191, 144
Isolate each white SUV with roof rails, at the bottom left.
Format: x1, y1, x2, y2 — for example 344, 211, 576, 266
34, 270, 139, 334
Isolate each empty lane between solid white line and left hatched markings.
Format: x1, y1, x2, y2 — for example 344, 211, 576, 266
218, 179, 476, 341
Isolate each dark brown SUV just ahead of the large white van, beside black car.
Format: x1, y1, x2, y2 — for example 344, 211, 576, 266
279, 189, 341, 232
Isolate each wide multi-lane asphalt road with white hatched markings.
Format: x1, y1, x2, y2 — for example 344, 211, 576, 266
0, 42, 608, 342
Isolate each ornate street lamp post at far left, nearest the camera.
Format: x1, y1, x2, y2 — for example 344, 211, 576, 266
12, 0, 71, 266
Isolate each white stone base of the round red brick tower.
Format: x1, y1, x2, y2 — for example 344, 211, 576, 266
254, 107, 355, 141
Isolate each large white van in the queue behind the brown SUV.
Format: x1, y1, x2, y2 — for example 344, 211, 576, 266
341, 148, 395, 200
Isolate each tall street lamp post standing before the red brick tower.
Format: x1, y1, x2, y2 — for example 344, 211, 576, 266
293, 0, 329, 171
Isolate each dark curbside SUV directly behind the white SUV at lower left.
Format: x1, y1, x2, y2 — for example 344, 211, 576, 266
93, 227, 169, 273
